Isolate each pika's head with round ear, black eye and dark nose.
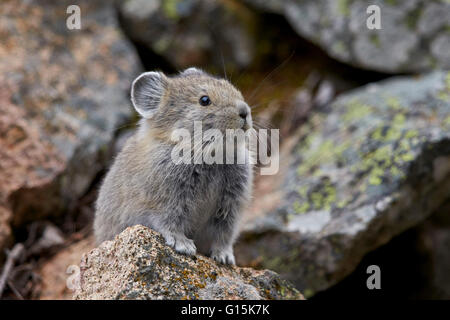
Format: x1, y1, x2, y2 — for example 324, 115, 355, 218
131, 68, 252, 139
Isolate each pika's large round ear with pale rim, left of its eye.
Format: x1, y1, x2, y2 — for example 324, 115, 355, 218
131, 71, 168, 119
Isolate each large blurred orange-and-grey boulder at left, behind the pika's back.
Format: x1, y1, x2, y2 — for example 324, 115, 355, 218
0, 0, 140, 252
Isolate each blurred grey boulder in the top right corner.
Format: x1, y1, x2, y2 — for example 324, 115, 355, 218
243, 0, 450, 73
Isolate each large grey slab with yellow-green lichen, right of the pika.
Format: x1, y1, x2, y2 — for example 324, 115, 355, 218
236, 72, 450, 297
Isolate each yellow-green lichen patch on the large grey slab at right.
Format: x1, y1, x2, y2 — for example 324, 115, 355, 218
294, 96, 428, 214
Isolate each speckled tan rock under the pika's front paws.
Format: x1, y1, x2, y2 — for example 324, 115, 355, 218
74, 225, 303, 299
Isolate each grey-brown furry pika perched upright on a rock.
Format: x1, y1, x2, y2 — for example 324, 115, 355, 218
94, 68, 253, 264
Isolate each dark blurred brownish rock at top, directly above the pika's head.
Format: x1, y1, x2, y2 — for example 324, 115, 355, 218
116, 0, 255, 72
